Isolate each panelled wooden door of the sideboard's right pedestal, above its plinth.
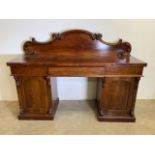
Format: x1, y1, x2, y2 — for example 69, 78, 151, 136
100, 77, 135, 115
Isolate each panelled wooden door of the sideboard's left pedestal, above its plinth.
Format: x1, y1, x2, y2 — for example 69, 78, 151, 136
16, 77, 51, 114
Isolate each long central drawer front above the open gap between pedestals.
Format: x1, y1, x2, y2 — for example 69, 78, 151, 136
48, 67, 104, 77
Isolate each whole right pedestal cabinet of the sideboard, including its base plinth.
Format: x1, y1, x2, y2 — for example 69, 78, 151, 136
97, 77, 139, 122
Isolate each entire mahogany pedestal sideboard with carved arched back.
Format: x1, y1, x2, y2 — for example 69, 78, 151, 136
7, 30, 147, 122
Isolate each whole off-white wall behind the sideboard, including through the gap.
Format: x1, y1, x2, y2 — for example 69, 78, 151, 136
0, 20, 155, 100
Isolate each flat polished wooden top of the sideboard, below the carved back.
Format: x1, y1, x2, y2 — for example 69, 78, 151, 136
7, 55, 147, 67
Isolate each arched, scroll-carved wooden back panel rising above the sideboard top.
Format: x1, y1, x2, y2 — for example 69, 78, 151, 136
23, 30, 131, 62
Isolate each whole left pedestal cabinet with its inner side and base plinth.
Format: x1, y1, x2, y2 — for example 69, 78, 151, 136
15, 76, 58, 119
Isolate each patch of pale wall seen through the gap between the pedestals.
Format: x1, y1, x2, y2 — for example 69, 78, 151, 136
57, 77, 97, 100
